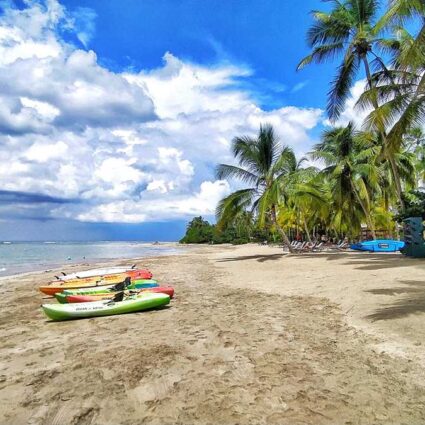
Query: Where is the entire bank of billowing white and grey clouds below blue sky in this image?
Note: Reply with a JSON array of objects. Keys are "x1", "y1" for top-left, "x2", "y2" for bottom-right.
[{"x1": 0, "y1": 0, "x2": 322, "y2": 222}]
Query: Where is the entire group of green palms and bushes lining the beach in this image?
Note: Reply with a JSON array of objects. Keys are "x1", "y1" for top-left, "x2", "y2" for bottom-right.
[{"x1": 184, "y1": 0, "x2": 425, "y2": 251}]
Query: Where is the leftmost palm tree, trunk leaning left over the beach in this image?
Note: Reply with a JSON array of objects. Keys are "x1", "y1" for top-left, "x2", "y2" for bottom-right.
[{"x1": 216, "y1": 124, "x2": 298, "y2": 252}]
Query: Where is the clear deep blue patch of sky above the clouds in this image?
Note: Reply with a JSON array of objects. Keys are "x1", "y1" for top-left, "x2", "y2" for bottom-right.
[{"x1": 63, "y1": 0, "x2": 334, "y2": 109}]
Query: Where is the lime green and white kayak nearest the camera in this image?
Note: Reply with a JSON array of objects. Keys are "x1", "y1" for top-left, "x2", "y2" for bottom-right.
[{"x1": 42, "y1": 293, "x2": 170, "y2": 320}]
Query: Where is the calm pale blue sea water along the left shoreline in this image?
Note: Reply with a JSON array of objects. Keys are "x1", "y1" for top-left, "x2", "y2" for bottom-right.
[{"x1": 0, "y1": 242, "x2": 180, "y2": 276}]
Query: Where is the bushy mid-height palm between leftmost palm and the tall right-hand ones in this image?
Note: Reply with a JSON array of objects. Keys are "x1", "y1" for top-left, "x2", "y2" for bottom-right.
[{"x1": 310, "y1": 123, "x2": 379, "y2": 239}]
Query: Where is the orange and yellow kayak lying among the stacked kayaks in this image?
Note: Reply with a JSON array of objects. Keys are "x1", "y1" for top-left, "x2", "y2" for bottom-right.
[{"x1": 39, "y1": 269, "x2": 152, "y2": 295}]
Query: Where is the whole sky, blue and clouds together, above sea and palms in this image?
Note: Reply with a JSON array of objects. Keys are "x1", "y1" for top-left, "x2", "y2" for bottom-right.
[{"x1": 0, "y1": 0, "x2": 360, "y2": 240}]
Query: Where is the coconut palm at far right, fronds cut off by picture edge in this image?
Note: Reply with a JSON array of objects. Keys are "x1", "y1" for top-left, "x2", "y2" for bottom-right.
[{"x1": 358, "y1": 0, "x2": 425, "y2": 202}]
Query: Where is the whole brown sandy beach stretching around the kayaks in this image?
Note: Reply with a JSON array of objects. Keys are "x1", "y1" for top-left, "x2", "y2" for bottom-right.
[{"x1": 0, "y1": 245, "x2": 425, "y2": 425}]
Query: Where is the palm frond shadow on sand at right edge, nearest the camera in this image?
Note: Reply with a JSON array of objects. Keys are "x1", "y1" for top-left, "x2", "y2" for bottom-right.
[{"x1": 365, "y1": 280, "x2": 425, "y2": 322}]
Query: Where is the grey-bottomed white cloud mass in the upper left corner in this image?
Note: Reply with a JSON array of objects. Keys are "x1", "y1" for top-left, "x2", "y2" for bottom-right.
[{"x1": 0, "y1": 9, "x2": 154, "y2": 132}]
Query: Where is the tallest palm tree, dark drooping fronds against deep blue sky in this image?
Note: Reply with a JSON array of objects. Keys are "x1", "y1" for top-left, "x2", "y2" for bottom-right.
[{"x1": 297, "y1": 0, "x2": 404, "y2": 208}]
